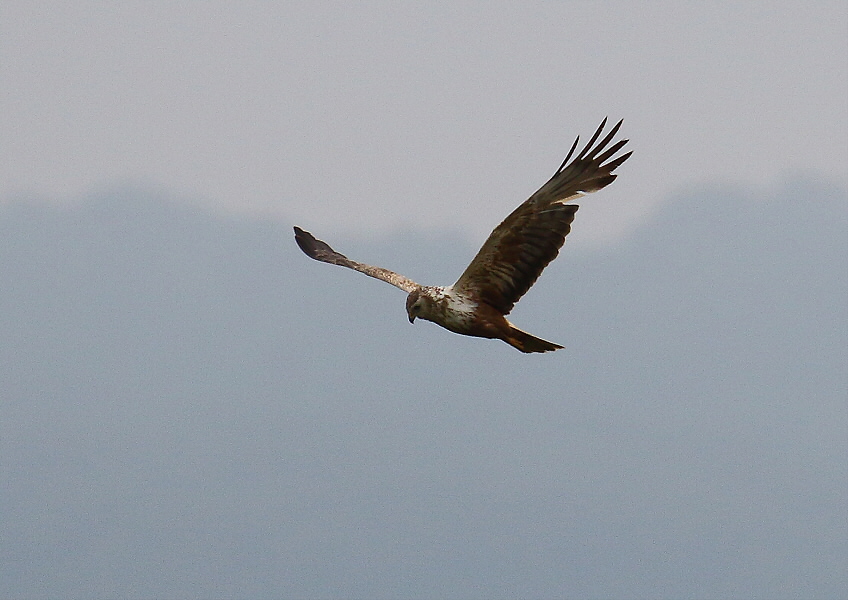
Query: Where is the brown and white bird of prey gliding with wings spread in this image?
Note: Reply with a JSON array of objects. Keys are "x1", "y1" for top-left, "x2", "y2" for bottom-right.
[{"x1": 294, "y1": 119, "x2": 631, "y2": 353}]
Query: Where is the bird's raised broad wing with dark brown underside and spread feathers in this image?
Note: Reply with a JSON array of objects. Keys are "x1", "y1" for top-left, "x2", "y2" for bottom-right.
[{"x1": 453, "y1": 119, "x2": 631, "y2": 315}]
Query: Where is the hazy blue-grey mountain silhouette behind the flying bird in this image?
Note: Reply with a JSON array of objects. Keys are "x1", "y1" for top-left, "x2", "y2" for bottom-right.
[{"x1": 0, "y1": 180, "x2": 848, "y2": 598}]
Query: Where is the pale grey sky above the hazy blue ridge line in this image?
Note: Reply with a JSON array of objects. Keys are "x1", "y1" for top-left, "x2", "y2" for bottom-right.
[{"x1": 0, "y1": 0, "x2": 848, "y2": 241}]
